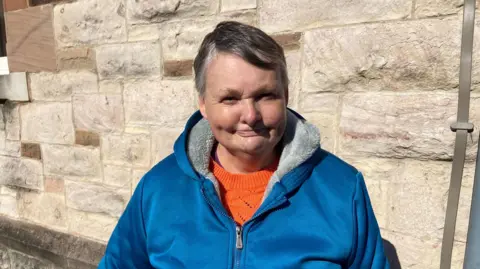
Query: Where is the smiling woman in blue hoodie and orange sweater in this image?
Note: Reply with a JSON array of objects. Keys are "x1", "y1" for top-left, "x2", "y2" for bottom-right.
[{"x1": 99, "y1": 22, "x2": 389, "y2": 269}]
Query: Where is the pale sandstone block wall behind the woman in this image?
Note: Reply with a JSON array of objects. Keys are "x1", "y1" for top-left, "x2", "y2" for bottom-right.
[{"x1": 0, "y1": 0, "x2": 480, "y2": 269}]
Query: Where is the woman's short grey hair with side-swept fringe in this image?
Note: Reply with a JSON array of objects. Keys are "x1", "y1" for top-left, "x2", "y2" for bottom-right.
[{"x1": 193, "y1": 21, "x2": 288, "y2": 96}]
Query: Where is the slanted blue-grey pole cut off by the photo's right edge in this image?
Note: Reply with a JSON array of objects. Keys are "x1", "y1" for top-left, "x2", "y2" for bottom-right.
[{"x1": 463, "y1": 131, "x2": 480, "y2": 269}]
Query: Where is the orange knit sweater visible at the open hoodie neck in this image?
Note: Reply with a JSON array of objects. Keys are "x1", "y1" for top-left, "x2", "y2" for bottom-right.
[{"x1": 210, "y1": 159, "x2": 278, "y2": 225}]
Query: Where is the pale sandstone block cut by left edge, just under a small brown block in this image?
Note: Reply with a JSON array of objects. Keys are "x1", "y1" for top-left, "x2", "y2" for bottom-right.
[{"x1": 0, "y1": 156, "x2": 43, "y2": 189}]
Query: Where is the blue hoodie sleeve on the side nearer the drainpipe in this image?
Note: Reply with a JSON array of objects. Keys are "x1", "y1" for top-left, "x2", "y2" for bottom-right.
[{"x1": 349, "y1": 173, "x2": 390, "y2": 269}]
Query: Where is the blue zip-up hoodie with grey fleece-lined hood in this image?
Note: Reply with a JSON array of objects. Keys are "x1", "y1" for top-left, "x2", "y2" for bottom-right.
[{"x1": 98, "y1": 110, "x2": 389, "y2": 269}]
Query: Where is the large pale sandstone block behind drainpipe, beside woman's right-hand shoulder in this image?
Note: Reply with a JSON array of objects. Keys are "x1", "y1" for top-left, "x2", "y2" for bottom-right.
[{"x1": 345, "y1": 157, "x2": 475, "y2": 241}]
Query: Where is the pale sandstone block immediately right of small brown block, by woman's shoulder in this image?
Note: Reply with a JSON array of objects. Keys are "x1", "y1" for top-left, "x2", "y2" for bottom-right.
[{"x1": 102, "y1": 134, "x2": 150, "y2": 166}]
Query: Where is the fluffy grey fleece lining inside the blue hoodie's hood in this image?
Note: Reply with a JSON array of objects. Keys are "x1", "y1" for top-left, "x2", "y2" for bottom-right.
[{"x1": 187, "y1": 111, "x2": 320, "y2": 202}]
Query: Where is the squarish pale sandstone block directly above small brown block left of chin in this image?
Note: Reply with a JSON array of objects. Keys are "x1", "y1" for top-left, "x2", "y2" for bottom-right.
[{"x1": 73, "y1": 94, "x2": 124, "y2": 132}]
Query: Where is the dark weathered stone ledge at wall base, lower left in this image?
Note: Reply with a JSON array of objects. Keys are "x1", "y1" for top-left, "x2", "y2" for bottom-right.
[{"x1": 0, "y1": 216, "x2": 106, "y2": 269}]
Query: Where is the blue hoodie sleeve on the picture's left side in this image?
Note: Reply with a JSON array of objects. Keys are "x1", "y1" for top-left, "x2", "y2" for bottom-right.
[{"x1": 98, "y1": 178, "x2": 152, "y2": 269}]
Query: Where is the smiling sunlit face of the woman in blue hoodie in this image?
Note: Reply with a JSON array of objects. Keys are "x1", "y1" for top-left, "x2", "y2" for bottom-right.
[{"x1": 199, "y1": 53, "x2": 288, "y2": 156}]
